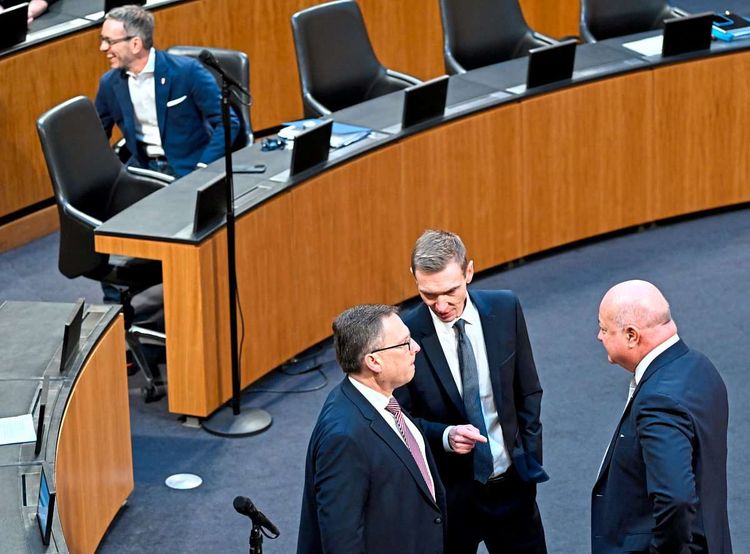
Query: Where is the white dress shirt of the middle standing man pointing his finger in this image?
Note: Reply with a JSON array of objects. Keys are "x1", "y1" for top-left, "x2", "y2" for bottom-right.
[{"x1": 430, "y1": 296, "x2": 510, "y2": 477}]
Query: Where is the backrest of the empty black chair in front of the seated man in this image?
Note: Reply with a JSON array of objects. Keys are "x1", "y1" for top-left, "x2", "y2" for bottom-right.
[{"x1": 37, "y1": 96, "x2": 122, "y2": 278}]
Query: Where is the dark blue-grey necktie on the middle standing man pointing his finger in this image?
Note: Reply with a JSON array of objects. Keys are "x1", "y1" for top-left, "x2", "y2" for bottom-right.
[{"x1": 453, "y1": 319, "x2": 494, "y2": 483}]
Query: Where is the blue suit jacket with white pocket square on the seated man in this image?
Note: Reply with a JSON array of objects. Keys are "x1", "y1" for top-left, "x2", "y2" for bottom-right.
[{"x1": 96, "y1": 50, "x2": 240, "y2": 176}]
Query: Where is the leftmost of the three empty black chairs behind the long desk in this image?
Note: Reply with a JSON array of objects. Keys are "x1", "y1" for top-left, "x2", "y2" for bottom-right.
[{"x1": 292, "y1": 0, "x2": 421, "y2": 117}]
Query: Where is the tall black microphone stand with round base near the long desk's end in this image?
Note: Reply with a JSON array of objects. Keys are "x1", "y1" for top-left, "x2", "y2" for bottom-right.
[{"x1": 201, "y1": 66, "x2": 272, "y2": 436}]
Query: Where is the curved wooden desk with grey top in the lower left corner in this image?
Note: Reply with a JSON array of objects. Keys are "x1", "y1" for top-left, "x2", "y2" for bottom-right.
[{"x1": 0, "y1": 302, "x2": 133, "y2": 553}]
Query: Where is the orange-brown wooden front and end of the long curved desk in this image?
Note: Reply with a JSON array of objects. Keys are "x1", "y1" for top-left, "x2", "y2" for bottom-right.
[{"x1": 96, "y1": 37, "x2": 750, "y2": 416}]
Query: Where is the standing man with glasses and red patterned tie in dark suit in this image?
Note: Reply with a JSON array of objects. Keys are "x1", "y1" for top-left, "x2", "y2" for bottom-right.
[{"x1": 297, "y1": 305, "x2": 445, "y2": 554}]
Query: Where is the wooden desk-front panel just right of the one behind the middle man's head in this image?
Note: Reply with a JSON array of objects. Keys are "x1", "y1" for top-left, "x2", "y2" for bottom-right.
[{"x1": 521, "y1": 71, "x2": 654, "y2": 253}]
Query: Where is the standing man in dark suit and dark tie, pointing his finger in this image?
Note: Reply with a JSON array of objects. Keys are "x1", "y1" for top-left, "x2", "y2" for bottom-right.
[{"x1": 396, "y1": 231, "x2": 547, "y2": 554}]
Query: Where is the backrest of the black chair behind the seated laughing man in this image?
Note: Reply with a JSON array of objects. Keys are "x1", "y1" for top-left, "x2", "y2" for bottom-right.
[{"x1": 167, "y1": 46, "x2": 253, "y2": 150}]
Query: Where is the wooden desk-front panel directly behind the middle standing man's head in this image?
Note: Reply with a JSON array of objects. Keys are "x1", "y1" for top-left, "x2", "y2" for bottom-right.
[{"x1": 402, "y1": 104, "x2": 522, "y2": 272}]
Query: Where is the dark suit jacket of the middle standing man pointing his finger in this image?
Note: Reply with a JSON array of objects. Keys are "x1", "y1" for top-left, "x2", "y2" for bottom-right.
[{"x1": 394, "y1": 291, "x2": 547, "y2": 492}]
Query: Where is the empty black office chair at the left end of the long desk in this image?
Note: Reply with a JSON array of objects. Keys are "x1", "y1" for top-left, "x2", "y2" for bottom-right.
[{"x1": 37, "y1": 96, "x2": 166, "y2": 401}]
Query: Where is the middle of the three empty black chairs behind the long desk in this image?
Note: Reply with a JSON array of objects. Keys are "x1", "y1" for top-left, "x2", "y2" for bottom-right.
[{"x1": 440, "y1": 0, "x2": 557, "y2": 75}]
